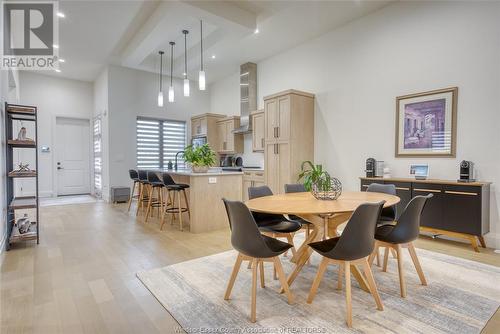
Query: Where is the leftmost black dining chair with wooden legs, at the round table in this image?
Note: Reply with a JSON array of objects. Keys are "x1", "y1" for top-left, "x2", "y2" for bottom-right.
[{"x1": 222, "y1": 199, "x2": 294, "y2": 322}]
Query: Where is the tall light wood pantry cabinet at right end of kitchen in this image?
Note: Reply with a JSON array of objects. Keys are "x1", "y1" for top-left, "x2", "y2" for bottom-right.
[{"x1": 264, "y1": 90, "x2": 314, "y2": 194}]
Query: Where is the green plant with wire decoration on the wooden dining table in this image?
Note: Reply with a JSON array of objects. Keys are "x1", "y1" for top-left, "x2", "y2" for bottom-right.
[{"x1": 299, "y1": 161, "x2": 342, "y2": 200}]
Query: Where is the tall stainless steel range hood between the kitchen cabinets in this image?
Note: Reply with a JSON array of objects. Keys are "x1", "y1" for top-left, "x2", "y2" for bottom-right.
[{"x1": 233, "y1": 63, "x2": 257, "y2": 134}]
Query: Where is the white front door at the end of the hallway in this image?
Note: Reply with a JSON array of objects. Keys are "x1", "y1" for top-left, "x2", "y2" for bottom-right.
[{"x1": 55, "y1": 117, "x2": 90, "y2": 195}]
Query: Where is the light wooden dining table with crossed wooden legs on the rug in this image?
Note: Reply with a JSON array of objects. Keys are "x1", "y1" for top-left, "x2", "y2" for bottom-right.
[{"x1": 245, "y1": 191, "x2": 400, "y2": 292}]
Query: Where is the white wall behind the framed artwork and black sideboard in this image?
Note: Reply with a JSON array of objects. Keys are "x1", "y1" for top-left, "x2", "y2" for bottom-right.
[{"x1": 211, "y1": 1, "x2": 500, "y2": 247}]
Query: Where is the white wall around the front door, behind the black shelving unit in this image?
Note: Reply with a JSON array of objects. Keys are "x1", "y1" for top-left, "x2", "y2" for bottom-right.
[{"x1": 19, "y1": 71, "x2": 94, "y2": 197}]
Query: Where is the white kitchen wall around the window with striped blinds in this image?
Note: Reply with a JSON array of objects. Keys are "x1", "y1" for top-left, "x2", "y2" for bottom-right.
[{"x1": 108, "y1": 66, "x2": 210, "y2": 194}]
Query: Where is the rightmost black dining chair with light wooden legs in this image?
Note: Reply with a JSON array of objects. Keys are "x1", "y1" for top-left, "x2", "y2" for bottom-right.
[{"x1": 370, "y1": 194, "x2": 432, "y2": 298}]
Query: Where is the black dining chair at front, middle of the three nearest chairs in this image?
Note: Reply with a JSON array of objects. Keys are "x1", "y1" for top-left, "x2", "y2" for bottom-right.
[{"x1": 307, "y1": 201, "x2": 385, "y2": 327}]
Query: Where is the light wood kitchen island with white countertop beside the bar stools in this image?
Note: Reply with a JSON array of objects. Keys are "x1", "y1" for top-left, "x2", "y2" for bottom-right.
[{"x1": 159, "y1": 168, "x2": 243, "y2": 233}]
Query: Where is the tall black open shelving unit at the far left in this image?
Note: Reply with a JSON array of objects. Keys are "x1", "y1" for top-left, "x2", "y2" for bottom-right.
[{"x1": 5, "y1": 103, "x2": 40, "y2": 250}]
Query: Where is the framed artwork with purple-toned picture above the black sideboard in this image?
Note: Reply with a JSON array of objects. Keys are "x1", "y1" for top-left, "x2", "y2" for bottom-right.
[{"x1": 396, "y1": 87, "x2": 458, "y2": 157}]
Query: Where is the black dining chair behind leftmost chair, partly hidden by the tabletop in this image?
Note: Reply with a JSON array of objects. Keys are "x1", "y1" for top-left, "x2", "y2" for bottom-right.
[{"x1": 248, "y1": 186, "x2": 302, "y2": 255}]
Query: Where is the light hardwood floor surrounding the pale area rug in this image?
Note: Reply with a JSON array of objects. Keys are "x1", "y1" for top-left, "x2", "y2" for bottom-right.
[{"x1": 0, "y1": 203, "x2": 500, "y2": 334}]
